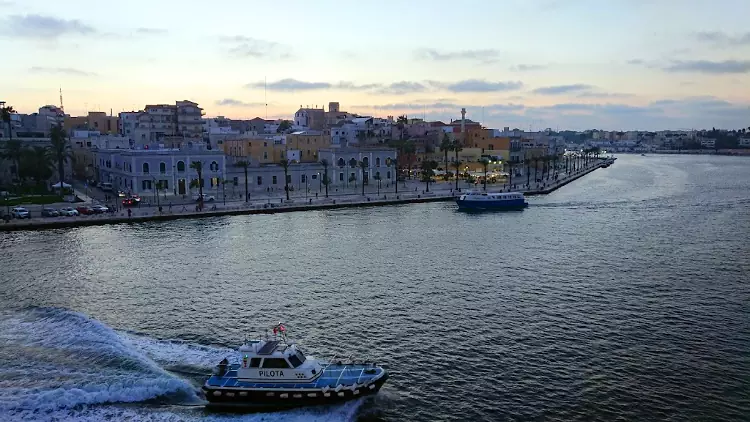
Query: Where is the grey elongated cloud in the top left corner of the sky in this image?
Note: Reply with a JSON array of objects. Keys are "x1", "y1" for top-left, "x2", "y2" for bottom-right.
[{"x1": 0, "y1": 14, "x2": 98, "y2": 40}]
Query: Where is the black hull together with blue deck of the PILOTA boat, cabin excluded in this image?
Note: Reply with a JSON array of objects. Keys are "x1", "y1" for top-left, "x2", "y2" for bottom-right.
[{"x1": 203, "y1": 365, "x2": 388, "y2": 409}]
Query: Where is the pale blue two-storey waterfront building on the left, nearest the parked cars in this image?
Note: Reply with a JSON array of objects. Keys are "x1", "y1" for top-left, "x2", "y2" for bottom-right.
[{"x1": 94, "y1": 143, "x2": 226, "y2": 195}]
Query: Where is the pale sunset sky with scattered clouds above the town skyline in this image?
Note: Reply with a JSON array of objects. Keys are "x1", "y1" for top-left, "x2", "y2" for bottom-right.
[{"x1": 0, "y1": 0, "x2": 750, "y2": 130}]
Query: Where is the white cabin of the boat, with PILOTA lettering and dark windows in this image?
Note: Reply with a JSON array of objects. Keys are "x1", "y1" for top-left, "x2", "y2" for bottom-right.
[{"x1": 237, "y1": 340, "x2": 323, "y2": 383}]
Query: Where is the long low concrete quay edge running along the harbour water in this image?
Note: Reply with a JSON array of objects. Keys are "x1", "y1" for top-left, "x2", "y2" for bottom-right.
[{"x1": 0, "y1": 160, "x2": 612, "y2": 231}]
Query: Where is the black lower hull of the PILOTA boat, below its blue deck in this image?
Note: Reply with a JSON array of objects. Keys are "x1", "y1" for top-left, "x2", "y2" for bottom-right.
[{"x1": 203, "y1": 373, "x2": 388, "y2": 408}]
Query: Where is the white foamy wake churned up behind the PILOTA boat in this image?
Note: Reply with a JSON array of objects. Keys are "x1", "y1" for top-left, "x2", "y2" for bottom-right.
[{"x1": 0, "y1": 307, "x2": 370, "y2": 421}]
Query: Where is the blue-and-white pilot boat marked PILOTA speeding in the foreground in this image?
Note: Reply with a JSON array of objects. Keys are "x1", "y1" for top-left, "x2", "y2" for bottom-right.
[{"x1": 203, "y1": 323, "x2": 388, "y2": 407}]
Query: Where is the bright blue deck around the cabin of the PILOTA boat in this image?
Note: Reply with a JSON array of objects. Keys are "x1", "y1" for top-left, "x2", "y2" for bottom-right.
[{"x1": 206, "y1": 364, "x2": 383, "y2": 389}]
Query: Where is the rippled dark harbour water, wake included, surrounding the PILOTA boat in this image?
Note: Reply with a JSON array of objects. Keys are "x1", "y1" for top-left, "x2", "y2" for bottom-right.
[{"x1": 0, "y1": 156, "x2": 750, "y2": 421}]
